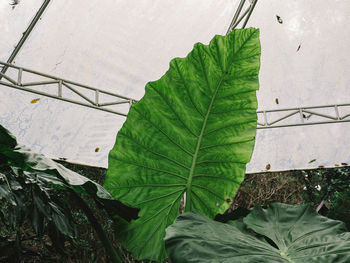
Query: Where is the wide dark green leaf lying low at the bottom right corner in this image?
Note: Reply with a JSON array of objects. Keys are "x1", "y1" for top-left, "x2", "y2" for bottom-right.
[{"x1": 166, "y1": 203, "x2": 350, "y2": 263}]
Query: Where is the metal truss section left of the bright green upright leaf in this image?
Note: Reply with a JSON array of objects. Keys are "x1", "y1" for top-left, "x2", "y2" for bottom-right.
[{"x1": 0, "y1": 61, "x2": 136, "y2": 117}]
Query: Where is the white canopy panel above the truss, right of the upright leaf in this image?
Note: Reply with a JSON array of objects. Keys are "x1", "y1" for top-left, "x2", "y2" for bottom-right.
[{"x1": 248, "y1": 0, "x2": 350, "y2": 109}]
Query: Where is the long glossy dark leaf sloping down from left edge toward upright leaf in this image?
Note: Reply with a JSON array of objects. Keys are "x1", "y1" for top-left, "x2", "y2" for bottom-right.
[{"x1": 0, "y1": 125, "x2": 138, "y2": 221}]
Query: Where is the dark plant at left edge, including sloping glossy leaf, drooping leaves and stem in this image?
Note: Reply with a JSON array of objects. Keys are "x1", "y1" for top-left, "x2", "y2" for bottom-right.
[{"x1": 0, "y1": 126, "x2": 138, "y2": 262}]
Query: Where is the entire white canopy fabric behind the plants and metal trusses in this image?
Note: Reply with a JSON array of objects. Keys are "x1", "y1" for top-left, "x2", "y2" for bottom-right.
[{"x1": 0, "y1": 0, "x2": 350, "y2": 172}]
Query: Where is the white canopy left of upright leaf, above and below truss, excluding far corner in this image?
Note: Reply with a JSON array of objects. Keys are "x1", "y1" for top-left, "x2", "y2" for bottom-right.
[{"x1": 0, "y1": 0, "x2": 237, "y2": 166}]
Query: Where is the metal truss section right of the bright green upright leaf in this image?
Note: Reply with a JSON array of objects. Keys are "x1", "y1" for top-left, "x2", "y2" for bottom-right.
[{"x1": 257, "y1": 104, "x2": 350, "y2": 129}]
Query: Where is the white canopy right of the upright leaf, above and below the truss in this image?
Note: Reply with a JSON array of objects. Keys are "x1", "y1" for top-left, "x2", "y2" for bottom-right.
[{"x1": 243, "y1": 0, "x2": 350, "y2": 172}]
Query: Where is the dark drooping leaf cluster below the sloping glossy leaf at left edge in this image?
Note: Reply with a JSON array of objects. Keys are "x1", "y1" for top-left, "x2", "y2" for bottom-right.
[{"x1": 0, "y1": 151, "x2": 76, "y2": 252}]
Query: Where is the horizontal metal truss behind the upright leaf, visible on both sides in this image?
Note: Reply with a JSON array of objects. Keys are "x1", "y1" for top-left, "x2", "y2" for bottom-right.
[{"x1": 0, "y1": 61, "x2": 350, "y2": 129}]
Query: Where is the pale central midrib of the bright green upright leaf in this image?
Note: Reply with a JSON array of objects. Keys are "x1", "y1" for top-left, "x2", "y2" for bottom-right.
[{"x1": 185, "y1": 31, "x2": 255, "y2": 212}]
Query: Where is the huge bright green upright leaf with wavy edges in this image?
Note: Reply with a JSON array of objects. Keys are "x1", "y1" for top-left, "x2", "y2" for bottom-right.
[{"x1": 105, "y1": 28, "x2": 260, "y2": 260}]
